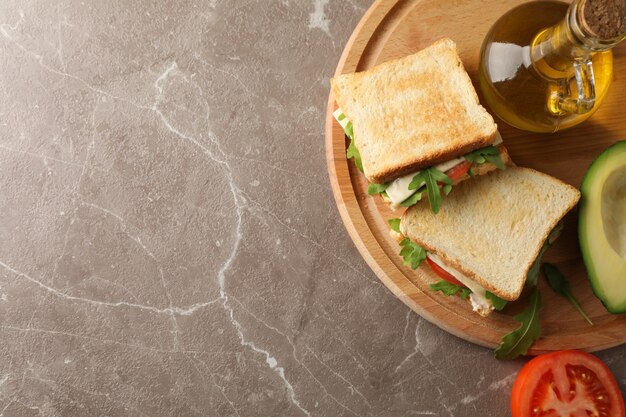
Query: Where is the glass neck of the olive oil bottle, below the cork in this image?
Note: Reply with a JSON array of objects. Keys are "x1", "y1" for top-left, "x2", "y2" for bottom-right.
[{"x1": 530, "y1": 0, "x2": 626, "y2": 80}]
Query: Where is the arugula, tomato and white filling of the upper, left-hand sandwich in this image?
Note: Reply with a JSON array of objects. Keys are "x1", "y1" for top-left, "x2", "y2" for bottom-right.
[{"x1": 333, "y1": 109, "x2": 504, "y2": 212}]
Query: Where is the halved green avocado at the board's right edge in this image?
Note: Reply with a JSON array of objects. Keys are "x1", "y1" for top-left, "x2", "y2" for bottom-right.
[{"x1": 578, "y1": 141, "x2": 626, "y2": 313}]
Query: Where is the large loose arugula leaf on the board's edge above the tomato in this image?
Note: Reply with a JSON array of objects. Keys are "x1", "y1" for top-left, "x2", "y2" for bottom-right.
[{"x1": 494, "y1": 287, "x2": 542, "y2": 359}]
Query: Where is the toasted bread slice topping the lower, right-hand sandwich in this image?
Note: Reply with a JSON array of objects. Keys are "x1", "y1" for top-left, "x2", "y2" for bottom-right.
[{"x1": 400, "y1": 167, "x2": 580, "y2": 301}]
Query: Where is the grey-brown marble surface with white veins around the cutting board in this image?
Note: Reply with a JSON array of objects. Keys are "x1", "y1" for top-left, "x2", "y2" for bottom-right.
[{"x1": 0, "y1": 0, "x2": 626, "y2": 417}]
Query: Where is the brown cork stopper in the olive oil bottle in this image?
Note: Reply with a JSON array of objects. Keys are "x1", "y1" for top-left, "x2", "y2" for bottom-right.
[{"x1": 581, "y1": 0, "x2": 626, "y2": 40}]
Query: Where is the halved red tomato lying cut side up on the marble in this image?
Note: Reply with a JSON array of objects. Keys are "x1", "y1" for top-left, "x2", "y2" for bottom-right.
[{"x1": 511, "y1": 350, "x2": 624, "y2": 417}]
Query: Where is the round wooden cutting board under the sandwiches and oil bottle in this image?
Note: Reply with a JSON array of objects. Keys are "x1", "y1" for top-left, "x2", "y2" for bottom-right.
[{"x1": 326, "y1": 0, "x2": 626, "y2": 354}]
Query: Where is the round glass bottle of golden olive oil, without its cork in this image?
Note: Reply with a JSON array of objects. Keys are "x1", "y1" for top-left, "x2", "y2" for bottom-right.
[{"x1": 479, "y1": 0, "x2": 626, "y2": 132}]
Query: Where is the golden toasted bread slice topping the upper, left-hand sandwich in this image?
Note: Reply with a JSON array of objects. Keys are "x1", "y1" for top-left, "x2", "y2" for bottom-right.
[{"x1": 331, "y1": 39, "x2": 497, "y2": 184}]
